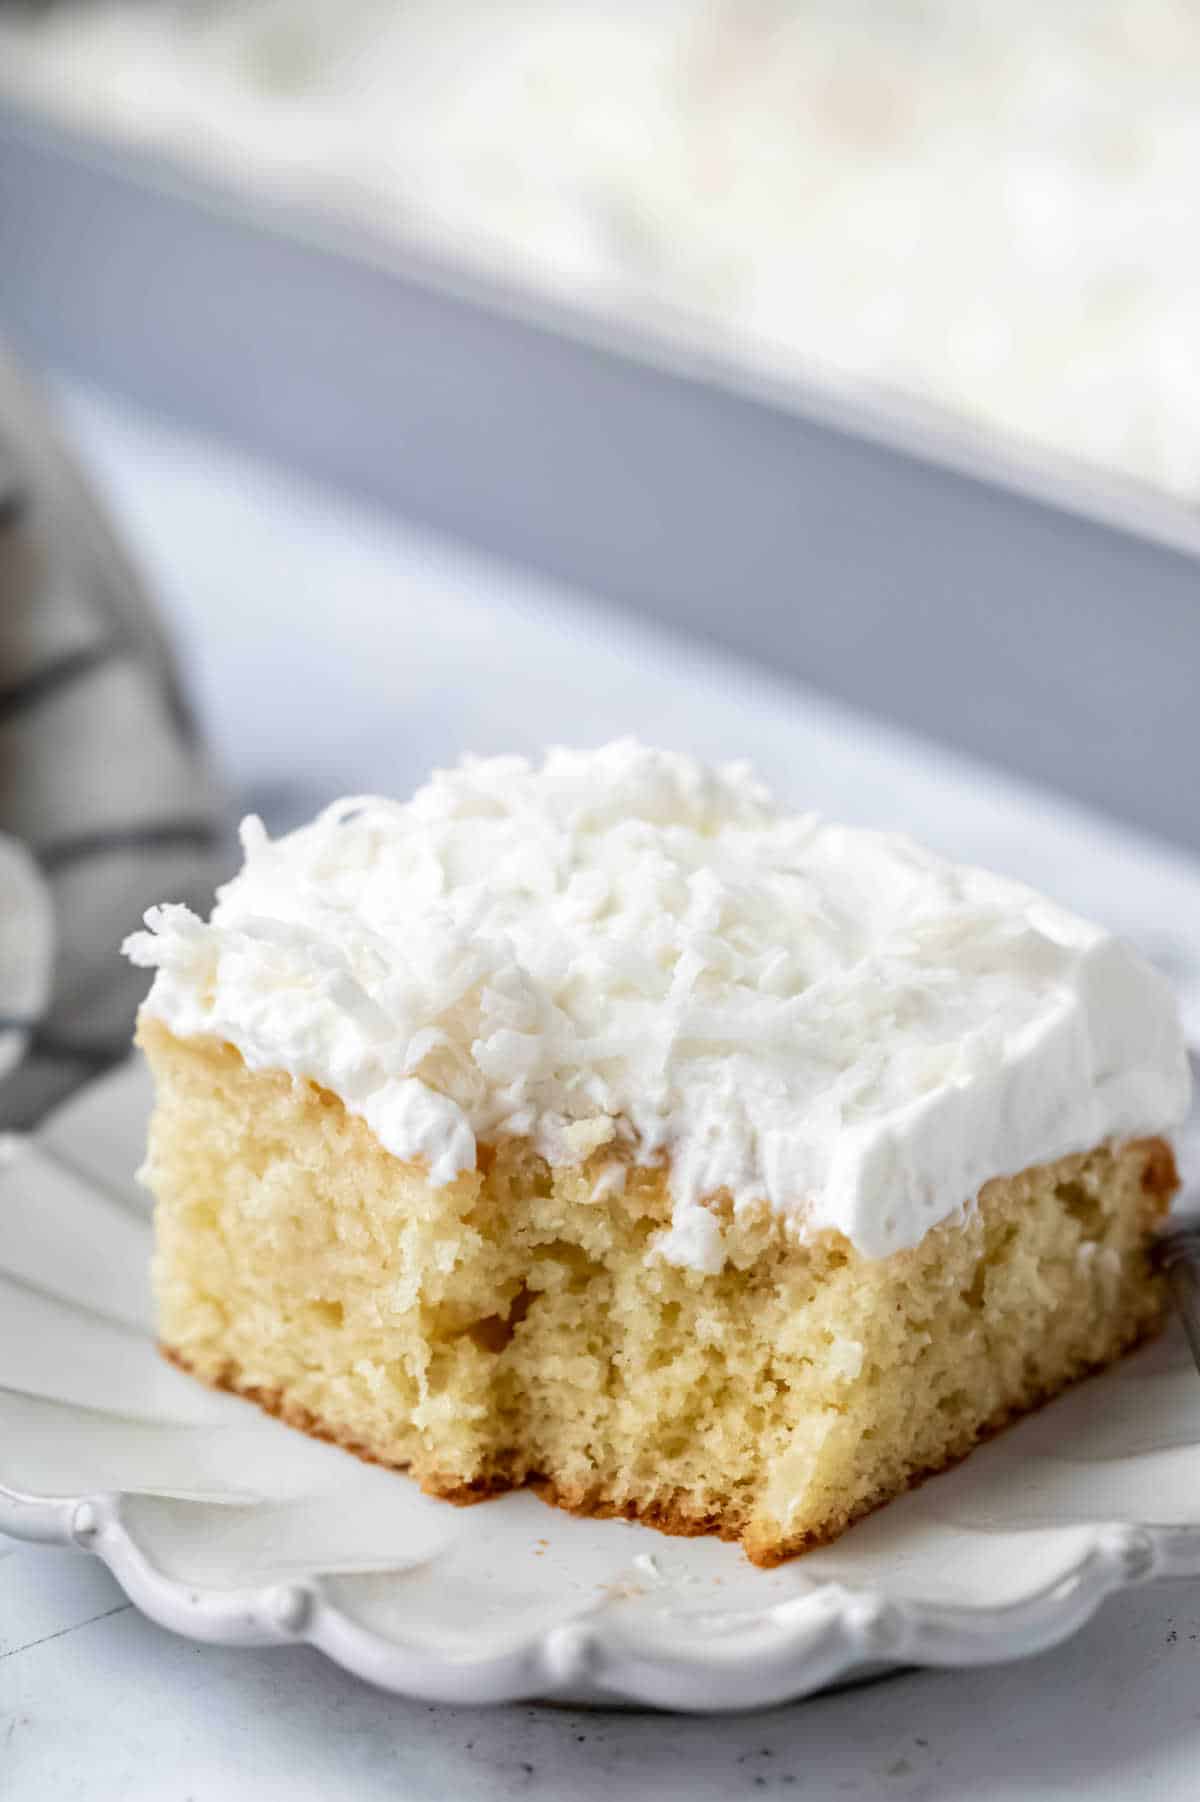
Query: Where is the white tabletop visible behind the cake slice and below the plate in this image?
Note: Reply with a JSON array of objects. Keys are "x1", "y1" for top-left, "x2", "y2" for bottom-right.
[{"x1": 0, "y1": 380, "x2": 1200, "y2": 1802}]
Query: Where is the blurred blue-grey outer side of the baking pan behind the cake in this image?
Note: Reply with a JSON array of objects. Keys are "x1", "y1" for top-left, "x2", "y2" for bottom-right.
[{"x1": 0, "y1": 108, "x2": 1200, "y2": 847}]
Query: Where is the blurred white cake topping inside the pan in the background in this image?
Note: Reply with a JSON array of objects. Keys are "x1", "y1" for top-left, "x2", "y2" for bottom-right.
[{"x1": 0, "y1": 0, "x2": 1200, "y2": 505}]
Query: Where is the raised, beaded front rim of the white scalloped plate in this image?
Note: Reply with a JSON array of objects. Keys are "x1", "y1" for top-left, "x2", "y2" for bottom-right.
[{"x1": 0, "y1": 1483, "x2": 1200, "y2": 1714}]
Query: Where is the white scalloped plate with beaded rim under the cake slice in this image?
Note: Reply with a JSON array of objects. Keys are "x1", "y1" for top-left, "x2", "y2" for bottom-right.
[{"x1": 0, "y1": 1065, "x2": 1200, "y2": 1710}]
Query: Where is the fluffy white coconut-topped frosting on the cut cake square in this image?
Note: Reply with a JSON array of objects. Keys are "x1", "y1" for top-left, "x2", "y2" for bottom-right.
[{"x1": 126, "y1": 741, "x2": 1189, "y2": 1270}]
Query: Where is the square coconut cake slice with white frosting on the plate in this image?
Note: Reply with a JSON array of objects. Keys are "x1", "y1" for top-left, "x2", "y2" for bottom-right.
[{"x1": 126, "y1": 742, "x2": 1189, "y2": 1564}]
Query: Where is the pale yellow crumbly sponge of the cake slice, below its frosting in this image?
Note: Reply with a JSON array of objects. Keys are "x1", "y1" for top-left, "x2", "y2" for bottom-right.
[{"x1": 141, "y1": 1020, "x2": 1177, "y2": 1564}]
